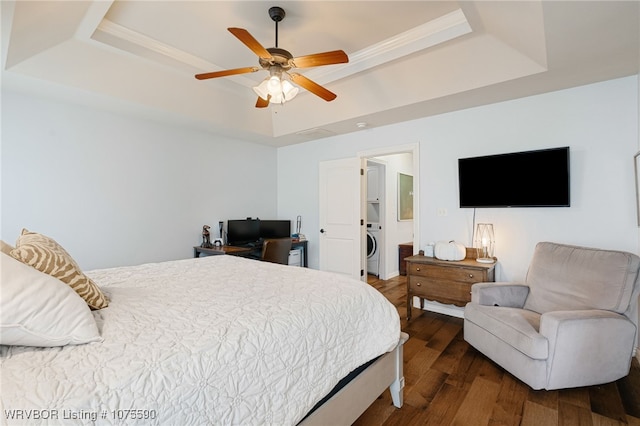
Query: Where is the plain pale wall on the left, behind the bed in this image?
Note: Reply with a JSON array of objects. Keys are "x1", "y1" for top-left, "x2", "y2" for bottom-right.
[{"x1": 1, "y1": 92, "x2": 278, "y2": 269}]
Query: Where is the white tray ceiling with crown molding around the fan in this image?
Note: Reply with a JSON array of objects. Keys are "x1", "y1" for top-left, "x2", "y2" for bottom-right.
[{"x1": 1, "y1": 0, "x2": 640, "y2": 146}]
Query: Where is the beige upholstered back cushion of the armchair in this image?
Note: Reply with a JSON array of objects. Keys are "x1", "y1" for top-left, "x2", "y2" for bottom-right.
[{"x1": 524, "y1": 242, "x2": 640, "y2": 314}]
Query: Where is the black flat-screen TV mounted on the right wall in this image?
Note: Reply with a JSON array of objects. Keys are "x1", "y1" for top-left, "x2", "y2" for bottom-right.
[{"x1": 458, "y1": 147, "x2": 570, "y2": 208}]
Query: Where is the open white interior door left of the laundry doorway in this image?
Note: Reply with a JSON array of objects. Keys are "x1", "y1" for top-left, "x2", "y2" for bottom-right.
[{"x1": 319, "y1": 158, "x2": 366, "y2": 279}]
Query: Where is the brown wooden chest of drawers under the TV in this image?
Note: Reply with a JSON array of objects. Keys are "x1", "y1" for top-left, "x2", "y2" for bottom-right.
[{"x1": 406, "y1": 255, "x2": 495, "y2": 319}]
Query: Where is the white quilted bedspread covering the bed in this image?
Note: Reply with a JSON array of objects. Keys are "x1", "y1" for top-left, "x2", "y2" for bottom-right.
[{"x1": 0, "y1": 256, "x2": 400, "y2": 425}]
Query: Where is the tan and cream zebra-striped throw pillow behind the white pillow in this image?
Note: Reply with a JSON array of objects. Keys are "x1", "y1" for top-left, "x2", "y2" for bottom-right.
[{"x1": 11, "y1": 229, "x2": 109, "y2": 309}]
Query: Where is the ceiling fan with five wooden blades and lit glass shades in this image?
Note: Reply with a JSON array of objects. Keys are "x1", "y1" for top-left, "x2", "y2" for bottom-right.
[{"x1": 195, "y1": 6, "x2": 349, "y2": 108}]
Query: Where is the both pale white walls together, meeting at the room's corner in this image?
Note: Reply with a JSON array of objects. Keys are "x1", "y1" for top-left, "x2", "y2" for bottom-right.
[{"x1": 1, "y1": 76, "x2": 640, "y2": 279}]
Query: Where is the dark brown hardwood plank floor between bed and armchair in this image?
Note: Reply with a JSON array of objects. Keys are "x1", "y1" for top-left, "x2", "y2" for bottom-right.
[{"x1": 354, "y1": 276, "x2": 640, "y2": 426}]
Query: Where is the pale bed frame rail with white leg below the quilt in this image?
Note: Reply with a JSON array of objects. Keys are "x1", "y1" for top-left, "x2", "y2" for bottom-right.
[{"x1": 299, "y1": 333, "x2": 409, "y2": 426}]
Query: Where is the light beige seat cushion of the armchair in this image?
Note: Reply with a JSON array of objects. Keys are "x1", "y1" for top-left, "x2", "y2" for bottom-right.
[{"x1": 464, "y1": 303, "x2": 549, "y2": 360}]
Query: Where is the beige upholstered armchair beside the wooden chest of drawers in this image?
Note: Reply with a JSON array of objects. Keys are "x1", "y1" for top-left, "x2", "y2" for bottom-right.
[{"x1": 464, "y1": 242, "x2": 640, "y2": 389}]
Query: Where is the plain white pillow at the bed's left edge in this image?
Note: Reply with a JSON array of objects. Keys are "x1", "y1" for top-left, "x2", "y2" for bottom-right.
[{"x1": 0, "y1": 253, "x2": 102, "y2": 346}]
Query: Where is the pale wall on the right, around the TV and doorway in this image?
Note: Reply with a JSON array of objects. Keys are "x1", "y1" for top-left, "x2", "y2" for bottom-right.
[{"x1": 278, "y1": 76, "x2": 639, "y2": 280}]
